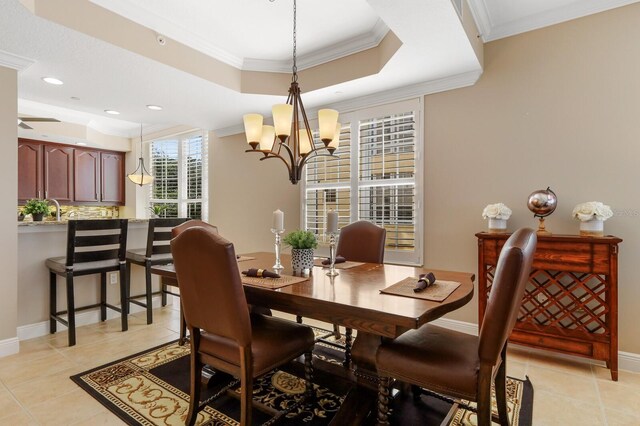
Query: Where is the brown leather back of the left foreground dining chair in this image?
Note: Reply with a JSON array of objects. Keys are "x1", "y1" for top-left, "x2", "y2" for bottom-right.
[{"x1": 171, "y1": 226, "x2": 251, "y2": 346}]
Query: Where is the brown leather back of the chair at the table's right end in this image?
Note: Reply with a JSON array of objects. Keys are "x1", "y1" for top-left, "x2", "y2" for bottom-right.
[{"x1": 478, "y1": 228, "x2": 538, "y2": 365}]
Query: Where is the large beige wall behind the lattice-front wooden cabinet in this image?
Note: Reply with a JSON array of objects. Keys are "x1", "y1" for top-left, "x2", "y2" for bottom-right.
[{"x1": 424, "y1": 4, "x2": 640, "y2": 353}]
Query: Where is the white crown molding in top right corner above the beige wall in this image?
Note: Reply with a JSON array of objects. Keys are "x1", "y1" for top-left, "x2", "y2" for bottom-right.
[{"x1": 469, "y1": 0, "x2": 638, "y2": 43}]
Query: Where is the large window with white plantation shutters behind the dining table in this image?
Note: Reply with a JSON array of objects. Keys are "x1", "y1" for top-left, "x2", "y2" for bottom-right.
[{"x1": 302, "y1": 99, "x2": 422, "y2": 264}]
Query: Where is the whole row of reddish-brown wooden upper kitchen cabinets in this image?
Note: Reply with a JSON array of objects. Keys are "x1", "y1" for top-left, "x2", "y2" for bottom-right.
[{"x1": 18, "y1": 139, "x2": 125, "y2": 205}]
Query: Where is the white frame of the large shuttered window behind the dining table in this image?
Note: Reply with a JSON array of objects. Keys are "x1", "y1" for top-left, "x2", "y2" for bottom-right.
[{"x1": 300, "y1": 98, "x2": 424, "y2": 266}]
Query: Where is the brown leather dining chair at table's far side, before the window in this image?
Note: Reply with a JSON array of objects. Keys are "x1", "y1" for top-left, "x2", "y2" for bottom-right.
[{"x1": 296, "y1": 220, "x2": 387, "y2": 367}]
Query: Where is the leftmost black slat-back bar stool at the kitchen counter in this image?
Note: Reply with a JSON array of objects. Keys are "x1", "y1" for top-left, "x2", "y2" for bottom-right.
[{"x1": 45, "y1": 219, "x2": 128, "y2": 346}]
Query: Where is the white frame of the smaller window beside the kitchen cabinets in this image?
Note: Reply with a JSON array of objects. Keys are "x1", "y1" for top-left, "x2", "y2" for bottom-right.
[{"x1": 145, "y1": 130, "x2": 209, "y2": 221}]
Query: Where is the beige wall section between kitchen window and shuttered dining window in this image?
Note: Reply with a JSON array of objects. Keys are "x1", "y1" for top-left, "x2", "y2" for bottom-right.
[{"x1": 209, "y1": 133, "x2": 300, "y2": 252}]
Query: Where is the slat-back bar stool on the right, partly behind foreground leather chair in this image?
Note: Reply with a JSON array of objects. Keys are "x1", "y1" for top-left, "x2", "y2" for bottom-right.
[{"x1": 126, "y1": 218, "x2": 189, "y2": 324}]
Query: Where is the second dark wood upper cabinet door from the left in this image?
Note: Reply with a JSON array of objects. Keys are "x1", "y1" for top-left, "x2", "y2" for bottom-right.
[{"x1": 44, "y1": 145, "x2": 74, "y2": 202}]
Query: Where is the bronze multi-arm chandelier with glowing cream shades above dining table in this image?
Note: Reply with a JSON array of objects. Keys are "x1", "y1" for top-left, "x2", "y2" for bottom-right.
[{"x1": 243, "y1": 0, "x2": 341, "y2": 185}]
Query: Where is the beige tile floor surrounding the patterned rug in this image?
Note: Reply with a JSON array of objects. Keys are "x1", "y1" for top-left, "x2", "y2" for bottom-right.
[{"x1": 0, "y1": 306, "x2": 640, "y2": 426}]
